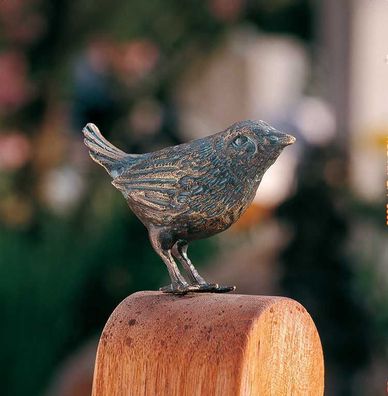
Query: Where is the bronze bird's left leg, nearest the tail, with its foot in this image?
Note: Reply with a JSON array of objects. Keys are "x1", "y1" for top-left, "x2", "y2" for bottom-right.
[{"x1": 150, "y1": 230, "x2": 189, "y2": 294}]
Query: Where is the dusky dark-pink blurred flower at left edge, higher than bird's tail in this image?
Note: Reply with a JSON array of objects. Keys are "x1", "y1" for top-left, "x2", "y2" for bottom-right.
[{"x1": 0, "y1": 51, "x2": 31, "y2": 110}]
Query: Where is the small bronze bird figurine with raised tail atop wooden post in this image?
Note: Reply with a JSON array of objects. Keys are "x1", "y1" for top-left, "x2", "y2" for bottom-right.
[{"x1": 83, "y1": 120, "x2": 296, "y2": 294}]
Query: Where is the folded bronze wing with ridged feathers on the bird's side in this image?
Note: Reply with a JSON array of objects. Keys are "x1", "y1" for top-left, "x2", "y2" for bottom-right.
[{"x1": 112, "y1": 139, "x2": 247, "y2": 218}]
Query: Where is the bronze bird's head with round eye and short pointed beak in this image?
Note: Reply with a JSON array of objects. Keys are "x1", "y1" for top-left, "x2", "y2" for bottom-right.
[{"x1": 223, "y1": 120, "x2": 296, "y2": 176}]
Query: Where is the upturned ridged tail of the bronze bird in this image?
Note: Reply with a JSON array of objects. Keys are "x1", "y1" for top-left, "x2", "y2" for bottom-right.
[{"x1": 82, "y1": 123, "x2": 131, "y2": 178}]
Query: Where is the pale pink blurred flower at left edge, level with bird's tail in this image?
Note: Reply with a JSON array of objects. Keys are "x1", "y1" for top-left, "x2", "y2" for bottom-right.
[{"x1": 0, "y1": 132, "x2": 31, "y2": 170}]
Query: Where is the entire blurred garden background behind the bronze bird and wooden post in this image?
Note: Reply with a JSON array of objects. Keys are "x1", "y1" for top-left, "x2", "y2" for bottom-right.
[{"x1": 0, "y1": 0, "x2": 388, "y2": 396}]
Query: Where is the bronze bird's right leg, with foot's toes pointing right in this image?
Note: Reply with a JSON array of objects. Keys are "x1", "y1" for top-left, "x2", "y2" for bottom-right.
[{"x1": 172, "y1": 240, "x2": 235, "y2": 293}]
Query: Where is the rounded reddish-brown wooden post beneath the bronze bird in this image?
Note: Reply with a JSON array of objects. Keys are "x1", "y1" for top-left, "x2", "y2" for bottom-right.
[{"x1": 92, "y1": 292, "x2": 324, "y2": 396}]
